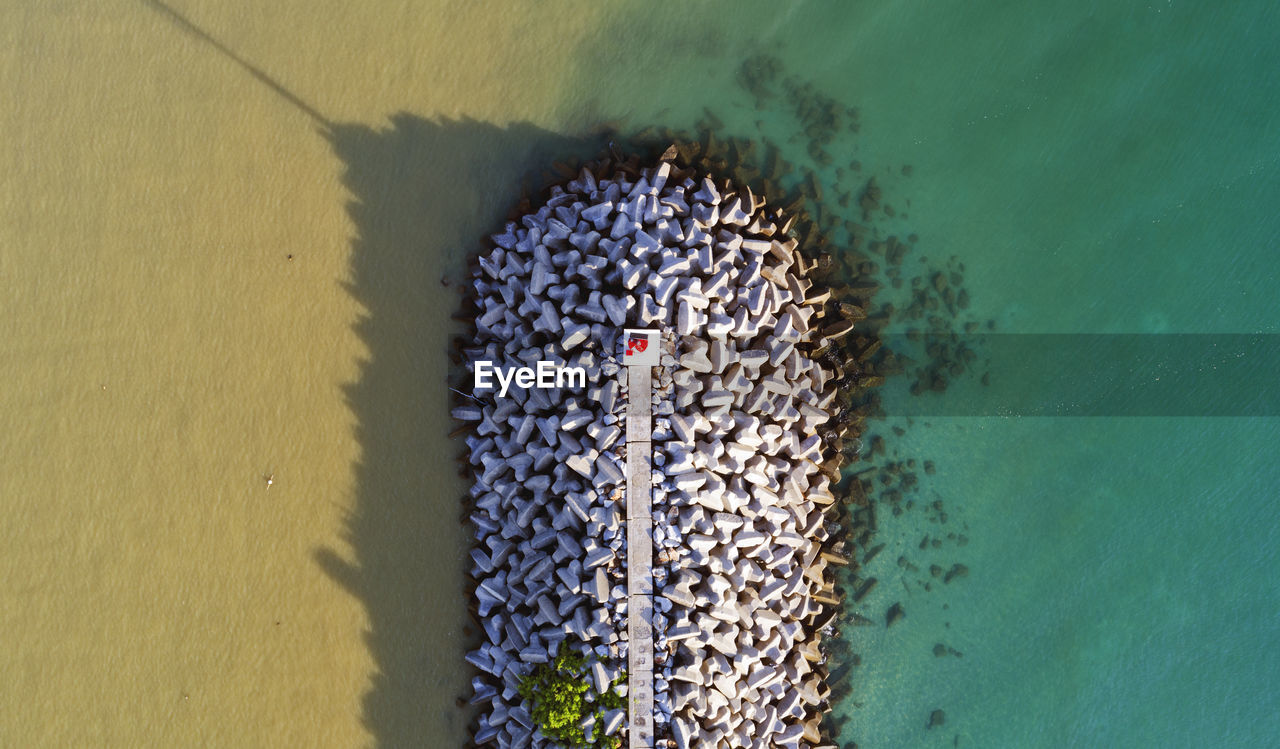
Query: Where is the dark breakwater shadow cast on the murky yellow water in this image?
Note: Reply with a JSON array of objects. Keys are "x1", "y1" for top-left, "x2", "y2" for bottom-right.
[{"x1": 315, "y1": 114, "x2": 595, "y2": 746}]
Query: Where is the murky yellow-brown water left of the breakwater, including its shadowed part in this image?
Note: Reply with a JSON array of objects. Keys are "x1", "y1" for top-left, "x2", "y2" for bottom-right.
[{"x1": 0, "y1": 0, "x2": 614, "y2": 746}]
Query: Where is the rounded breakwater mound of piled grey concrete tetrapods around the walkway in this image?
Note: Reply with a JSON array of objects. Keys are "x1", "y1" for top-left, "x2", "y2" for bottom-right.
[{"x1": 453, "y1": 147, "x2": 861, "y2": 746}]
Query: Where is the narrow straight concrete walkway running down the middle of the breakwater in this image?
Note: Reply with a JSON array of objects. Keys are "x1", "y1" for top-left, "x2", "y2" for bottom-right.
[{"x1": 626, "y1": 366, "x2": 653, "y2": 749}]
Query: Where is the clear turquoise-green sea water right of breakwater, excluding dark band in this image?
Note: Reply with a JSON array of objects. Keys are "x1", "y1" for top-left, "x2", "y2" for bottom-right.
[{"x1": 570, "y1": 0, "x2": 1280, "y2": 746}]
